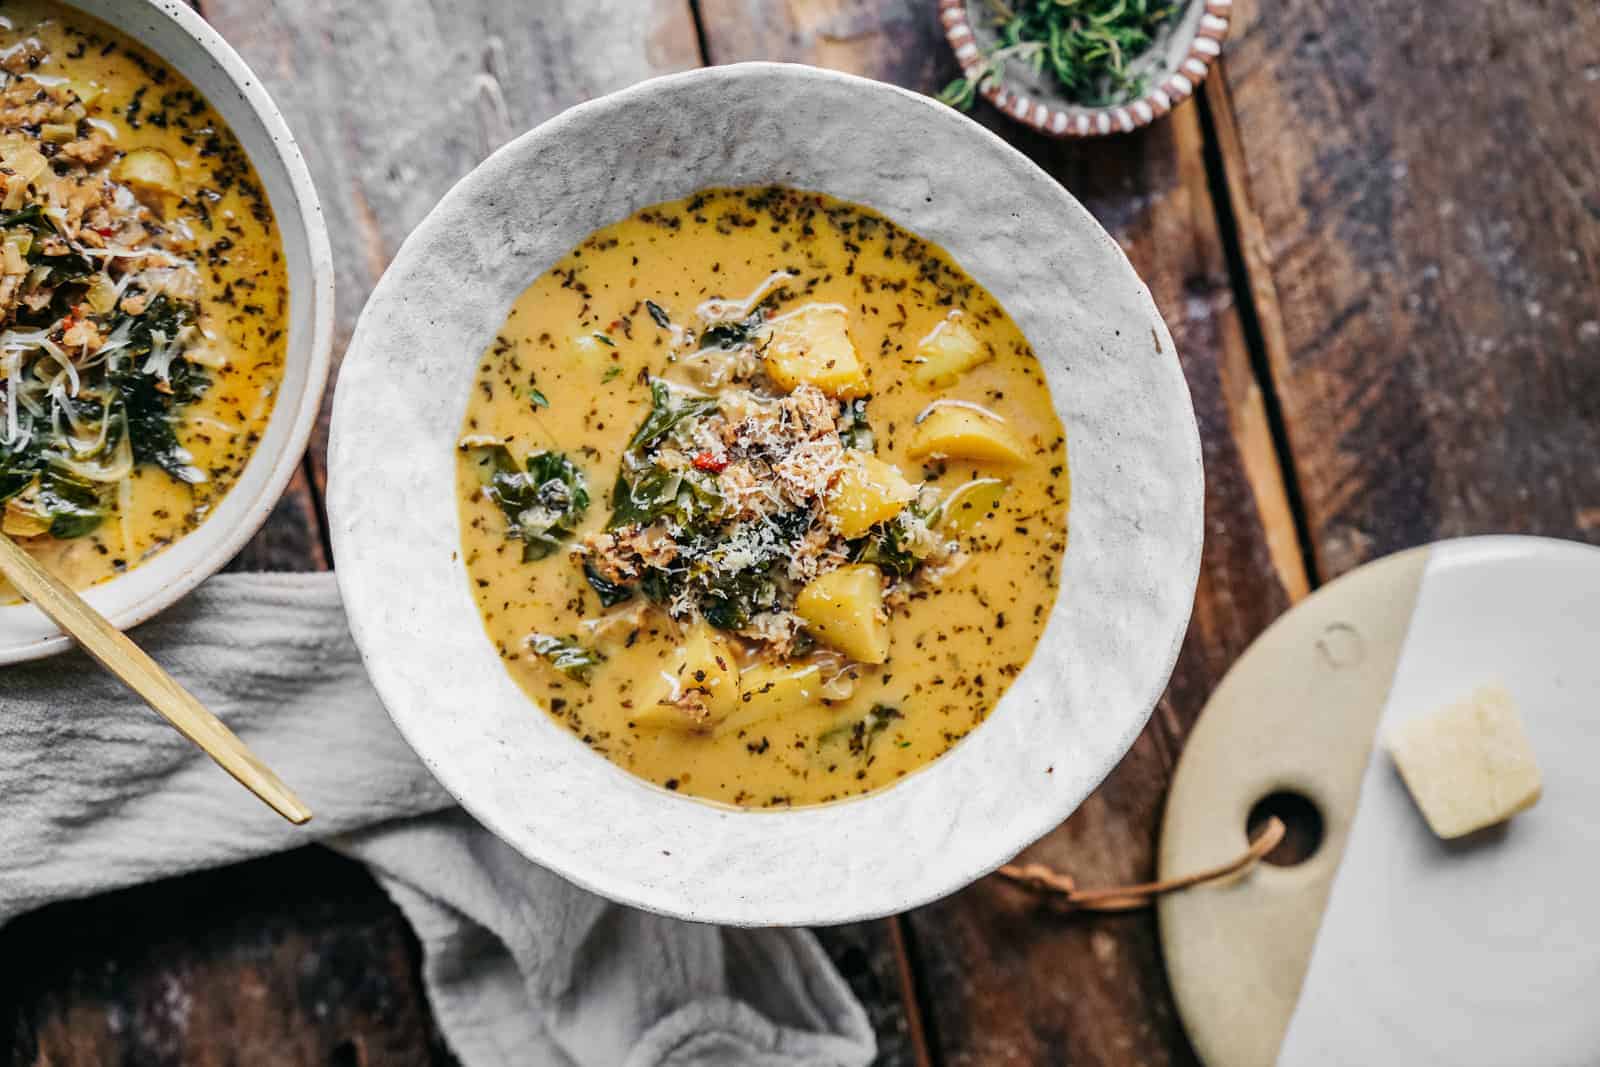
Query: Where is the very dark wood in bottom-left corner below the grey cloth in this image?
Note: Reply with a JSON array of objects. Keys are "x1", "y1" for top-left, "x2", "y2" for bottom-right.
[{"x1": 0, "y1": 848, "x2": 454, "y2": 1067}]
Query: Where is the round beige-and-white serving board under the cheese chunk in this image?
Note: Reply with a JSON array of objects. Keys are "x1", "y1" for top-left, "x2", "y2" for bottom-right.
[{"x1": 1158, "y1": 536, "x2": 1600, "y2": 1067}]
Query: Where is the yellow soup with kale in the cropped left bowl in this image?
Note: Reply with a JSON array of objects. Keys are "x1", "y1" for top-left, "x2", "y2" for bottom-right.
[{"x1": 0, "y1": 0, "x2": 288, "y2": 601}]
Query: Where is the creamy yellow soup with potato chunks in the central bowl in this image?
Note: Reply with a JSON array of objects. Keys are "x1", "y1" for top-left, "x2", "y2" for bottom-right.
[{"x1": 458, "y1": 189, "x2": 1069, "y2": 806}]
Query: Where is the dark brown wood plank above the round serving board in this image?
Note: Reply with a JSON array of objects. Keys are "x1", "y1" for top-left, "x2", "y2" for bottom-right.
[{"x1": 1226, "y1": 0, "x2": 1600, "y2": 577}]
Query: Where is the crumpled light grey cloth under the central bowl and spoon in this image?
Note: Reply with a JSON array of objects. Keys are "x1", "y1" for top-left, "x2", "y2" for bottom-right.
[{"x1": 0, "y1": 574, "x2": 874, "y2": 1067}]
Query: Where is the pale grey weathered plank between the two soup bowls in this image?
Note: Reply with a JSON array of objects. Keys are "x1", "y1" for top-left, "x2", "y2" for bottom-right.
[{"x1": 202, "y1": 0, "x2": 699, "y2": 488}]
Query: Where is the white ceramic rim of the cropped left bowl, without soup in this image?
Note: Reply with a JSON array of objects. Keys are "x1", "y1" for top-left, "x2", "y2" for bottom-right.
[{"x1": 0, "y1": 0, "x2": 333, "y2": 664}]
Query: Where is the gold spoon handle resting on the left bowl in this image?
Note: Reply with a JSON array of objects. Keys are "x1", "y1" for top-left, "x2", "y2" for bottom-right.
[{"x1": 0, "y1": 533, "x2": 310, "y2": 825}]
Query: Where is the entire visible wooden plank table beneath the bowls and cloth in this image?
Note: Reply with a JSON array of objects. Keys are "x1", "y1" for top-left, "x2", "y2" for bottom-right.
[{"x1": 0, "y1": 0, "x2": 1600, "y2": 1067}]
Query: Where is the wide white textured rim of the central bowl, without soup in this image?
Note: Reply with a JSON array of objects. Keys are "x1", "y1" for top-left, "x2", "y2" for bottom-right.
[{"x1": 328, "y1": 64, "x2": 1202, "y2": 925}]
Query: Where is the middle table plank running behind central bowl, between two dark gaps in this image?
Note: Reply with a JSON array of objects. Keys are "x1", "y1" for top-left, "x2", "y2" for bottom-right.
[{"x1": 701, "y1": 0, "x2": 1307, "y2": 1067}]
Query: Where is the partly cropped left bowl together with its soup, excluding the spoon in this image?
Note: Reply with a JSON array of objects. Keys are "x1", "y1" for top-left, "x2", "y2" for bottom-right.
[{"x1": 0, "y1": 0, "x2": 333, "y2": 664}]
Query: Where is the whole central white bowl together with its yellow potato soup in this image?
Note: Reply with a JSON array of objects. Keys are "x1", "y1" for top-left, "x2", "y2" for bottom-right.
[{"x1": 330, "y1": 64, "x2": 1200, "y2": 923}]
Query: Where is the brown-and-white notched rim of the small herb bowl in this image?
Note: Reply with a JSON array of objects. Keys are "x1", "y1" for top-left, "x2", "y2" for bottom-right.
[{"x1": 939, "y1": 0, "x2": 1234, "y2": 138}]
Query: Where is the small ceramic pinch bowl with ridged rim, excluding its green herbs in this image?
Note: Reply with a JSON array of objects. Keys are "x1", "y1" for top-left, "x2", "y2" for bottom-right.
[{"x1": 939, "y1": 0, "x2": 1234, "y2": 138}]
